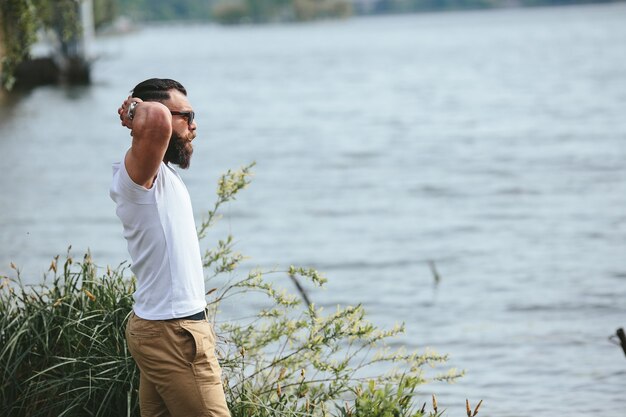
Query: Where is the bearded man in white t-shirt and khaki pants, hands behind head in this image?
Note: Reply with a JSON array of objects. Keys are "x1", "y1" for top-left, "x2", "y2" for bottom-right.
[{"x1": 110, "y1": 78, "x2": 230, "y2": 417}]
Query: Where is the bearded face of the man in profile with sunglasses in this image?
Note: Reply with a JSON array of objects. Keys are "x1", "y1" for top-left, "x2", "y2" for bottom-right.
[{"x1": 163, "y1": 90, "x2": 197, "y2": 169}]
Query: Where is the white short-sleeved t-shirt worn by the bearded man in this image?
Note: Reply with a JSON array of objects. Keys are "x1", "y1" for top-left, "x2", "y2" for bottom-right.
[{"x1": 110, "y1": 158, "x2": 206, "y2": 320}]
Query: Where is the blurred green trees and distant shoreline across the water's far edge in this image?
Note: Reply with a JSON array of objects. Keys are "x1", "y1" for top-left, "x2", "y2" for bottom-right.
[{"x1": 0, "y1": 0, "x2": 624, "y2": 90}]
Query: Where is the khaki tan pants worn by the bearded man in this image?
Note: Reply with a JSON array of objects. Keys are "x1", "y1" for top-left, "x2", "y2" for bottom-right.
[{"x1": 126, "y1": 313, "x2": 230, "y2": 417}]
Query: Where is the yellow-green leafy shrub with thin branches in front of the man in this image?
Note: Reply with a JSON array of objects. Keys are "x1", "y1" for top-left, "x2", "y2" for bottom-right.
[{"x1": 199, "y1": 162, "x2": 460, "y2": 416}]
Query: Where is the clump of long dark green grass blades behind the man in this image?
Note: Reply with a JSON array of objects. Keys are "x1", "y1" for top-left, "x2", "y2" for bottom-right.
[{"x1": 0, "y1": 251, "x2": 138, "y2": 416}]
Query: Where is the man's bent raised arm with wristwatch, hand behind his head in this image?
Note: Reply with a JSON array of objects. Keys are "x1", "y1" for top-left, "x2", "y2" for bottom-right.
[{"x1": 117, "y1": 97, "x2": 172, "y2": 188}]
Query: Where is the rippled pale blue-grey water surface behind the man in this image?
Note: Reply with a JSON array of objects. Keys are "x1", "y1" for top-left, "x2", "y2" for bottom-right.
[{"x1": 0, "y1": 4, "x2": 626, "y2": 417}]
